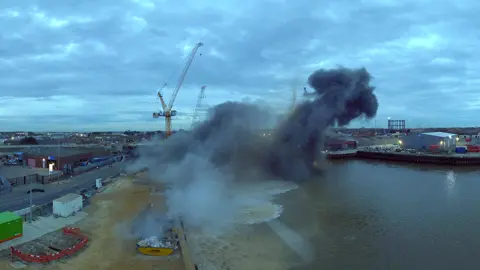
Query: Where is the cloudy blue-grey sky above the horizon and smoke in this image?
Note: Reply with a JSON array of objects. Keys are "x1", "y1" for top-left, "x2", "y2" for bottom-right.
[{"x1": 0, "y1": 0, "x2": 480, "y2": 131}]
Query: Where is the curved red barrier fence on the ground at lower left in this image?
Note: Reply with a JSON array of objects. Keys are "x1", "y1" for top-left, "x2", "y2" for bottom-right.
[{"x1": 10, "y1": 227, "x2": 88, "y2": 263}]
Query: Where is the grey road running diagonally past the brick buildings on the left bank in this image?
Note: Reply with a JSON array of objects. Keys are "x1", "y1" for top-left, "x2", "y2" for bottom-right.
[{"x1": 0, "y1": 162, "x2": 126, "y2": 212}]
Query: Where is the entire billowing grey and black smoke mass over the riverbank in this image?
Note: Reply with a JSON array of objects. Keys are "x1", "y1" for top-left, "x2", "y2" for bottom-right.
[{"x1": 131, "y1": 68, "x2": 378, "y2": 232}]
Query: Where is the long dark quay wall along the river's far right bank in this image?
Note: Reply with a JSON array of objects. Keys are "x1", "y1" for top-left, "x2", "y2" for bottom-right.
[{"x1": 327, "y1": 150, "x2": 480, "y2": 166}]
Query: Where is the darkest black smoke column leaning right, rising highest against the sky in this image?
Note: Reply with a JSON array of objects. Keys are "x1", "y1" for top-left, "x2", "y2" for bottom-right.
[{"x1": 269, "y1": 67, "x2": 378, "y2": 180}]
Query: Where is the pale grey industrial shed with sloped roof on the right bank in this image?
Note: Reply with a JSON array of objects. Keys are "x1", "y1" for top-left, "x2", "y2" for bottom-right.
[{"x1": 401, "y1": 132, "x2": 458, "y2": 151}]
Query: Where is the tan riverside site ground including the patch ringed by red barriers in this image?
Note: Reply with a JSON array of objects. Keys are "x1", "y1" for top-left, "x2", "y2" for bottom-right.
[{"x1": 0, "y1": 173, "x2": 185, "y2": 269}]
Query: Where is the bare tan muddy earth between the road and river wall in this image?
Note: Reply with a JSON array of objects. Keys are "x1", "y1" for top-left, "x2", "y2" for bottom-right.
[{"x1": 0, "y1": 175, "x2": 185, "y2": 270}]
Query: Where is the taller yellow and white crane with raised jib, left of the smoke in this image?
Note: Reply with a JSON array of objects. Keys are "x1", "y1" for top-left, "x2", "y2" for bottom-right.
[{"x1": 153, "y1": 42, "x2": 203, "y2": 138}]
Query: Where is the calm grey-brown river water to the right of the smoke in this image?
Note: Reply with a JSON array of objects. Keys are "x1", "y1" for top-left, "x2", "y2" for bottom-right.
[{"x1": 280, "y1": 161, "x2": 480, "y2": 270}]
